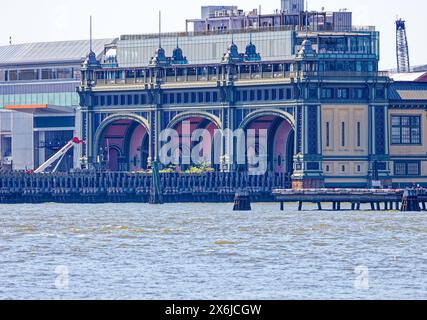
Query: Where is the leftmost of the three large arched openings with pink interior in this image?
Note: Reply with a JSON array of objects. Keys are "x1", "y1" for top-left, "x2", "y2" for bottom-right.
[{"x1": 95, "y1": 116, "x2": 149, "y2": 171}]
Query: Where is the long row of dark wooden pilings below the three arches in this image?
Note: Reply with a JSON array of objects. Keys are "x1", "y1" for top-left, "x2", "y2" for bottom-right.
[{"x1": 0, "y1": 171, "x2": 291, "y2": 203}]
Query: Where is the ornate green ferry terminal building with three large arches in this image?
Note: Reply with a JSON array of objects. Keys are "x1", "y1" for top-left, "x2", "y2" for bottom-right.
[{"x1": 79, "y1": 30, "x2": 398, "y2": 188}]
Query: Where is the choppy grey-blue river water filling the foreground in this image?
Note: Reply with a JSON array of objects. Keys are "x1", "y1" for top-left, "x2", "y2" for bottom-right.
[{"x1": 0, "y1": 204, "x2": 427, "y2": 299}]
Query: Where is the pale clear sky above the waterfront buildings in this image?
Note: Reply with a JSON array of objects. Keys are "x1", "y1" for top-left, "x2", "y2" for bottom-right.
[{"x1": 0, "y1": 0, "x2": 427, "y2": 69}]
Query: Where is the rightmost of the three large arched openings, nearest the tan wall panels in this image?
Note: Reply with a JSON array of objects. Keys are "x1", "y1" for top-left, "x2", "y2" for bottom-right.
[{"x1": 241, "y1": 112, "x2": 295, "y2": 175}]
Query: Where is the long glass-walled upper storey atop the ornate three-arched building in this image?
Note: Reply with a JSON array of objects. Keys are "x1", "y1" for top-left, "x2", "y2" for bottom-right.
[{"x1": 115, "y1": 26, "x2": 379, "y2": 71}]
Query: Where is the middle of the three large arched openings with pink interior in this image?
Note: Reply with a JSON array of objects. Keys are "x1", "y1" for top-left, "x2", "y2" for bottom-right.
[{"x1": 169, "y1": 113, "x2": 221, "y2": 171}]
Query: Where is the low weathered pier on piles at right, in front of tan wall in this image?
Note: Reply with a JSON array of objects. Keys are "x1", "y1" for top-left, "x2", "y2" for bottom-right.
[{"x1": 273, "y1": 189, "x2": 427, "y2": 211}]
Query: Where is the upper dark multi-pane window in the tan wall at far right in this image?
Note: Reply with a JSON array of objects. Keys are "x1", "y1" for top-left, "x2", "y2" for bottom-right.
[{"x1": 391, "y1": 116, "x2": 421, "y2": 145}]
